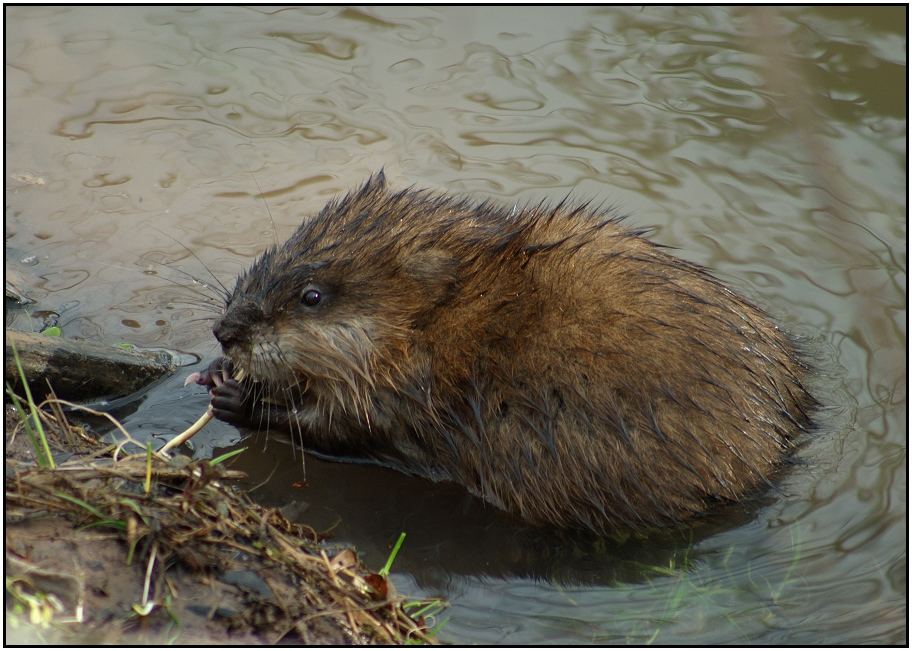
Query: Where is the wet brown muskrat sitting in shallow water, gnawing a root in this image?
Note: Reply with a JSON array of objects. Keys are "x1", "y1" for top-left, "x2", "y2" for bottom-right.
[{"x1": 200, "y1": 172, "x2": 814, "y2": 533}]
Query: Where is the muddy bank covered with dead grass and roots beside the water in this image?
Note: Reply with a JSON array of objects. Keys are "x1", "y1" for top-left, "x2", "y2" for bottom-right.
[{"x1": 4, "y1": 407, "x2": 442, "y2": 645}]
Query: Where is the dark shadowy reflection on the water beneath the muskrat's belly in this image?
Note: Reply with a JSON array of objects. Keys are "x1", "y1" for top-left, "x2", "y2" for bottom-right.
[{"x1": 219, "y1": 435, "x2": 773, "y2": 592}]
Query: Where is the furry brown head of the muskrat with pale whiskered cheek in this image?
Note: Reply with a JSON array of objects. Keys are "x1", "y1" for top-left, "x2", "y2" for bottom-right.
[{"x1": 213, "y1": 174, "x2": 456, "y2": 416}]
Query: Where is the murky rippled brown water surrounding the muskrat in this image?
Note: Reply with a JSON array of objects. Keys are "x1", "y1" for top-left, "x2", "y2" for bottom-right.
[{"x1": 5, "y1": 7, "x2": 908, "y2": 644}]
